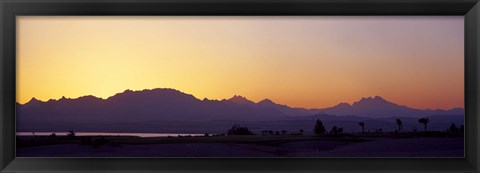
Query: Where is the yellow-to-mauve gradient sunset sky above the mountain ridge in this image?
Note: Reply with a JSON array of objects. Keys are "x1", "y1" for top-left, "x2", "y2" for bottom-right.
[{"x1": 17, "y1": 16, "x2": 464, "y2": 109}]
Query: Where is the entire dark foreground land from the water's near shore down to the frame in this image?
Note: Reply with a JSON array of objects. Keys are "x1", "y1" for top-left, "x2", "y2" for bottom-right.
[{"x1": 17, "y1": 135, "x2": 464, "y2": 157}]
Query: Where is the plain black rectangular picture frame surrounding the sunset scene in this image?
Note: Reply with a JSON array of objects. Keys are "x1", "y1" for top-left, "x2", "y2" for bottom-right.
[{"x1": 0, "y1": 0, "x2": 480, "y2": 173}]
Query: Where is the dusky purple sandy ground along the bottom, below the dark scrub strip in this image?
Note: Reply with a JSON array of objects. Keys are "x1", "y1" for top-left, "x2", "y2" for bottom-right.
[{"x1": 17, "y1": 138, "x2": 464, "y2": 157}]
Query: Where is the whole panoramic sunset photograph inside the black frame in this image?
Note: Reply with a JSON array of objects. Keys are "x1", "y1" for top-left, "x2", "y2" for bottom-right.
[{"x1": 16, "y1": 16, "x2": 465, "y2": 158}]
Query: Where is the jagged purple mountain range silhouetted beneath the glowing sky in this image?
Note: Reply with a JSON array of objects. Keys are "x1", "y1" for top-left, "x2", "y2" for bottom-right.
[{"x1": 17, "y1": 88, "x2": 464, "y2": 124}]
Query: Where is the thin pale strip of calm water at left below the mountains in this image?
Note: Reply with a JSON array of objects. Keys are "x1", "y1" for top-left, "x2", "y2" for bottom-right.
[{"x1": 16, "y1": 132, "x2": 204, "y2": 137}]
